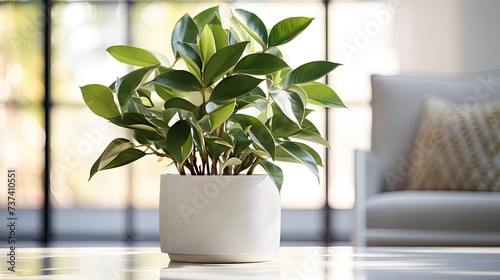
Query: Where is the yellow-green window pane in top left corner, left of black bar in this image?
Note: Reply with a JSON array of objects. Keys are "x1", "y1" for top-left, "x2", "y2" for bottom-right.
[{"x1": 0, "y1": 3, "x2": 44, "y2": 103}]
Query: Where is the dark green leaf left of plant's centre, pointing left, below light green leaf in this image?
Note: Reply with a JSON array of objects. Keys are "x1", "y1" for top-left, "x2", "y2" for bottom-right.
[{"x1": 153, "y1": 70, "x2": 201, "y2": 92}]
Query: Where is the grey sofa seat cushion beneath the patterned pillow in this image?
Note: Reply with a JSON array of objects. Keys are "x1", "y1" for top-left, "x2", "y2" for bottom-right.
[{"x1": 366, "y1": 191, "x2": 500, "y2": 232}]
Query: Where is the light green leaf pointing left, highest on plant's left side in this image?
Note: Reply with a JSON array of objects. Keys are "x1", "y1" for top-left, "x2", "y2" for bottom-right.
[{"x1": 106, "y1": 46, "x2": 160, "y2": 67}]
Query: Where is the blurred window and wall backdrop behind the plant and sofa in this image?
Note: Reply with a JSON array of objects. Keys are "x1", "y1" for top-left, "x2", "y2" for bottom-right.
[{"x1": 0, "y1": 0, "x2": 500, "y2": 246}]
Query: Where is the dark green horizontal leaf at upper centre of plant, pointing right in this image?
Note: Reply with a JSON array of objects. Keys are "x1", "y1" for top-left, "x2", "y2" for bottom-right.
[{"x1": 233, "y1": 53, "x2": 289, "y2": 75}]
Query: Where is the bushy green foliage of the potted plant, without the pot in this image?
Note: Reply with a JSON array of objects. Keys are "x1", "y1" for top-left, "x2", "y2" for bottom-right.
[{"x1": 81, "y1": 6, "x2": 345, "y2": 189}]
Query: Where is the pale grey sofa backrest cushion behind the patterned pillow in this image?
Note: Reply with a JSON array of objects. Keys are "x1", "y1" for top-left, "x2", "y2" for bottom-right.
[{"x1": 371, "y1": 69, "x2": 500, "y2": 190}]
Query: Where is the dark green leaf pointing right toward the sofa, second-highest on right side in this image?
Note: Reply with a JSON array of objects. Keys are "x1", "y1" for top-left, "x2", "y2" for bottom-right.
[{"x1": 284, "y1": 61, "x2": 340, "y2": 88}]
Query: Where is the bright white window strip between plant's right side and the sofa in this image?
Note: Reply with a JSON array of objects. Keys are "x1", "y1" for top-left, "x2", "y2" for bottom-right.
[{"x1": 328, "y1": 2, "x2": 399, "y2": 208}]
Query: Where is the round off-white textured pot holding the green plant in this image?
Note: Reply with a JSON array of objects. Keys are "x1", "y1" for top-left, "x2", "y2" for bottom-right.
[{"x1": 159, "y1": 174, "x2": 281, "y2": 263}]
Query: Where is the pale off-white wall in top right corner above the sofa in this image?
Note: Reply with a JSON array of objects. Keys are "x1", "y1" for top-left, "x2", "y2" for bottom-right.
[{"x1": 394, "y1": 0, "x2": 500, "y2": 74}]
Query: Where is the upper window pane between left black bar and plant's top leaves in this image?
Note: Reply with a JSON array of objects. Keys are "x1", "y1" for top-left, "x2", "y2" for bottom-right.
[{"x1": 51, "y1": 2, "x2": 126, "y2": 103}]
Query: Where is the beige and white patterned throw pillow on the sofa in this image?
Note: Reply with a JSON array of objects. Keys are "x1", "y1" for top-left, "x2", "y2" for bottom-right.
[{"x1": 406, "y1": 96, "x2": 500, "y2": 191}]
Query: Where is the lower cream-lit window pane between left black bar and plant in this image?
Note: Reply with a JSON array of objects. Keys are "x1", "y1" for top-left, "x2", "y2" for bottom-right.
[{"x1": 51, "y1": 107, "x2": 130, "y2": 208}]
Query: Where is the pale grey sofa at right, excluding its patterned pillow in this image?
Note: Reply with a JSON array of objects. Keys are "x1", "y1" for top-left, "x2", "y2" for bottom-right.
[{"x1": 351, "y1": 70, "x2": 500, "y2": 246}]
